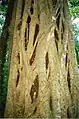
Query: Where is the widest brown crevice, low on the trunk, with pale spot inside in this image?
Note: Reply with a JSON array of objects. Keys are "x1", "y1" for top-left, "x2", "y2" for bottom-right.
[{"x1": 30, "y1": 75, "x2": 39, "y2": 103}]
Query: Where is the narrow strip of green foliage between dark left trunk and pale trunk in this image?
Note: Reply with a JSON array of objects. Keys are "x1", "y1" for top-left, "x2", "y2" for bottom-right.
[{"x1": 0, "y1": 39, "x2": 9, "y2": 117}]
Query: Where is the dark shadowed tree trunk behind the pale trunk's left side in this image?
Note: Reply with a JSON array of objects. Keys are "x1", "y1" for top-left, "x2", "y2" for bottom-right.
[{"x1": 0, "y1": 0, "x2": 15, "y2": 117}]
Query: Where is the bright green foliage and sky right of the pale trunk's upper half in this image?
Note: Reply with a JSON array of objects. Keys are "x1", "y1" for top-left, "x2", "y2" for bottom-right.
[{"x1": 69, "y1": 0, "x2": 79, "y2": 66}]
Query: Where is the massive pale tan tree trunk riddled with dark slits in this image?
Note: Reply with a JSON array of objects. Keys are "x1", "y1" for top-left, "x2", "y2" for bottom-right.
[{"x1": 5, "y1": 0, "x2": 79, "y2": 118}]
